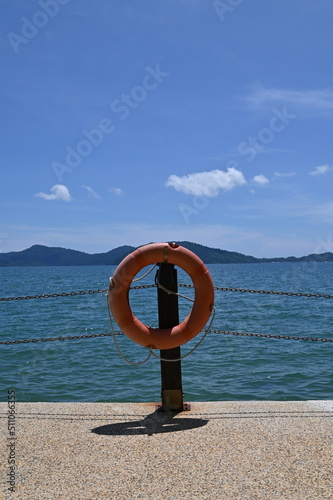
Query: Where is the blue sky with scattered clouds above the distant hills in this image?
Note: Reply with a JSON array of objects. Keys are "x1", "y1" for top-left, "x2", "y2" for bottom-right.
[{"x1": 0, "y1": 0, "x2": 333, "y2": 257}]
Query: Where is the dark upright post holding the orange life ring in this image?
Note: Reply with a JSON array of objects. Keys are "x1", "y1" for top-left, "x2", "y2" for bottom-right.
[{"x1": 157, "y1": 262, "x2": 183, "y2": 411}]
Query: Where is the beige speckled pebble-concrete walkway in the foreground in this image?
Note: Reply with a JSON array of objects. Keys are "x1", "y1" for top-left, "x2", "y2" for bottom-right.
[{"x1": 0, "y1": 401, "x2": 333, "y2": 500}]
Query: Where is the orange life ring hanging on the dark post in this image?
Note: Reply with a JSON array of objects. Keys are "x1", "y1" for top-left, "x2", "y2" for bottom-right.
[{"x1": 108, "y1": 243, "x2": 214, "y2": 349}]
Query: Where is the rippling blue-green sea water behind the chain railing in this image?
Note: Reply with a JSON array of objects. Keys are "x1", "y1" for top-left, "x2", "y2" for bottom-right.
[{"x1": 0, "y1": 263, "x2": 333, "y2": 402}]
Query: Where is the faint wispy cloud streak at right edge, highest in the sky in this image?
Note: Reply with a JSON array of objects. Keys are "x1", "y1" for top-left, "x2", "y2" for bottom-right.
[{"x1": 246, "y1": 84, "x2": 333, "y2": 110}]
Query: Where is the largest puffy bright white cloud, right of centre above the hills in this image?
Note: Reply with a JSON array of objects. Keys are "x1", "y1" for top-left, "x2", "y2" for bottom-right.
[{"x1": 165, "y1": 167, "x2": 246, "y2": 198}]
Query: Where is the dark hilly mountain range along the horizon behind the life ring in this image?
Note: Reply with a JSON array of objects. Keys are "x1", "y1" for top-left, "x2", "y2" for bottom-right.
[{"x1": 0, "y1": 241, "x2": 333, "y2": 267}]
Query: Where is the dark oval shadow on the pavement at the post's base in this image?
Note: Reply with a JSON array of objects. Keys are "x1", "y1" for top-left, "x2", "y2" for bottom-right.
[{"x1": 91, "y1": 410, "x2": 208, "y2": 436}]
